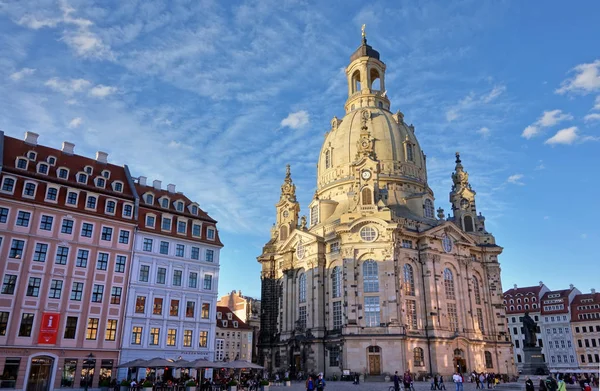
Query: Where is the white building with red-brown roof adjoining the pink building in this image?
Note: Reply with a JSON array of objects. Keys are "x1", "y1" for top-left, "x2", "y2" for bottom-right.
[{"x1": 119, "y1": 181, "x2": 222, "y2": 378}]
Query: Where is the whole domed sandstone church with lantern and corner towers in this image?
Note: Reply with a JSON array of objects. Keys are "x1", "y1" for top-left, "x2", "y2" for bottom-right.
[{"x1": 258, "y1": 35, "x2": 514, "y2": 376}]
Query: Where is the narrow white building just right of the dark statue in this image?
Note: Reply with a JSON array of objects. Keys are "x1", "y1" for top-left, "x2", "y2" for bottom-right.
[{"x1": 539, "y1": 285, "x2": 581, "y2": 373}]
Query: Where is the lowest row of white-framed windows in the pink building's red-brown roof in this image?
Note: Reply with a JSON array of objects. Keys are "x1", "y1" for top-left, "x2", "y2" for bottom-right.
[{"x1": 0, "y1": 176, "x2": 133, "y2": 218}]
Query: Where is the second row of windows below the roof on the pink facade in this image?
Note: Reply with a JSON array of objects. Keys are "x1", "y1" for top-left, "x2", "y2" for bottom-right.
[{"x1": 8, "y1": 239, "x2": 127, "y2": 273}]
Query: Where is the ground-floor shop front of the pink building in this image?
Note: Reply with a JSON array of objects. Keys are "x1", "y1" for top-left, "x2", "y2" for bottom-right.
[{"x1": 0, "y1": 348, "x2": 119, "y2": 391}]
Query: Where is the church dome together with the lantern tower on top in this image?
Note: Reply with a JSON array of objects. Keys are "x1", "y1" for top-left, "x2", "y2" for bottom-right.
[{"x1": 317, "y1": 38, "x2": 432, "y2": 205}]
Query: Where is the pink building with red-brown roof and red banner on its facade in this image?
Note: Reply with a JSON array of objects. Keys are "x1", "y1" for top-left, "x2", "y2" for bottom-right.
[{"x1": 0, "y1": 132, "x2": 136, "y2": 391}]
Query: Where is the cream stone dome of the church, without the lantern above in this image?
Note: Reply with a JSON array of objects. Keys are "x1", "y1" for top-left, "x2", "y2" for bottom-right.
[{"x1": 317, "y1": 107, "x2": 427, "y2": 196}]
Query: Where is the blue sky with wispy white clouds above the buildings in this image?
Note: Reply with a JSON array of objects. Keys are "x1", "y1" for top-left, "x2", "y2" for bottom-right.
[{"x1": 0, "y1": 0, "x2": 600, "y2": 296}]
